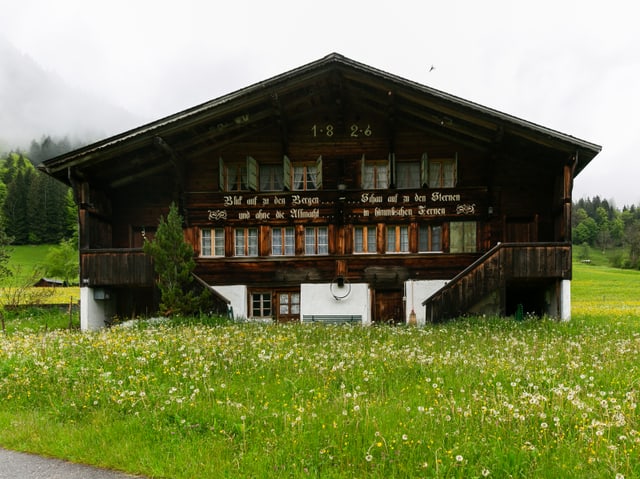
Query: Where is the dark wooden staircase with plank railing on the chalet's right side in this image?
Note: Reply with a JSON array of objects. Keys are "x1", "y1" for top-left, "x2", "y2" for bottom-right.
[{"x1": 422, "y1": 243, "x2": 571, "y2": 322}]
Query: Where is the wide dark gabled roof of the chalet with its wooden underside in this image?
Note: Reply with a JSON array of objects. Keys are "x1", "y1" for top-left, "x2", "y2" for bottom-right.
[{"x1": 40, "y1": 53, "x2": 601, "y2": 188}]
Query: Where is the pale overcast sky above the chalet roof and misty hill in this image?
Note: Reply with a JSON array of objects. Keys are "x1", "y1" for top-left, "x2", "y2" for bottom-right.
[{"x1": 0, "y1": 0, "x2": 640, "y2": 207}]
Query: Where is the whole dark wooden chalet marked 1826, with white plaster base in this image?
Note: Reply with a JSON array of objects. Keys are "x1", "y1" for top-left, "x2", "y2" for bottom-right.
[{"x1": 42, "y1": 54, "x2": 601, "y2": 329}]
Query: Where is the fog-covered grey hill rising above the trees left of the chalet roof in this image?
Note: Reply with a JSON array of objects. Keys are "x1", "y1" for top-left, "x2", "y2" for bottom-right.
[{"x1": 0, "y1": 35, "x2": 142, "y2": 152}]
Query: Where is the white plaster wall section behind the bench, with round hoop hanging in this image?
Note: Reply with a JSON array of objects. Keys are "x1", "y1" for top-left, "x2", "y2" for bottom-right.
[{"x1": 300, "y1": 283, "x2": 371, "y2": 324}]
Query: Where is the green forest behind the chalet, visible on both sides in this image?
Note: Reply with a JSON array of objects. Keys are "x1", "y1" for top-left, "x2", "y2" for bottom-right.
[{"x1": 0, "y1": 136, "x2": 640, "y2": 269}]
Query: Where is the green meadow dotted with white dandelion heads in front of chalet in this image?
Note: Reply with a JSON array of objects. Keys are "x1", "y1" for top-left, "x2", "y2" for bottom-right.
[{"x1": 0, "y1": 263, "x2": 640, "y2": 479}]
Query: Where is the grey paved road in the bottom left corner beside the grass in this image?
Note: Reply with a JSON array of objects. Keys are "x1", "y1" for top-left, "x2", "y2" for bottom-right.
[{"x1": 0, "y1": 449, "x2": 145, "y2": 479}]
